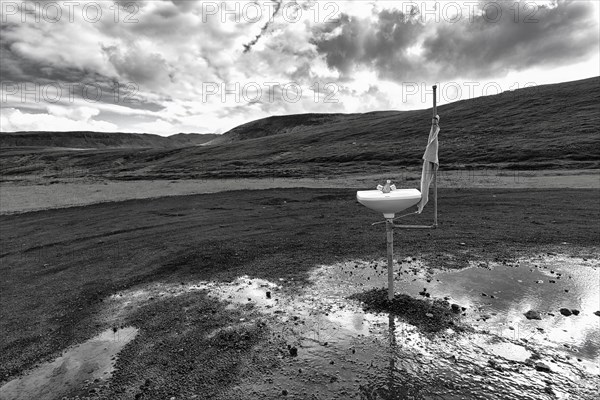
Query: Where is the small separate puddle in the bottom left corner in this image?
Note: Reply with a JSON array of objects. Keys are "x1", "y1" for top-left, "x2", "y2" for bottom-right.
[{"x1": 0, "y1": 327, "x2": 137, "y2": 400}]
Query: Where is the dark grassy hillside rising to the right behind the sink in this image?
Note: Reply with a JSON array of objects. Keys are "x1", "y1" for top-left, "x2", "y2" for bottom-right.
[{"x1": 1, "y1": 77, "x2": 600, "y2": 179}]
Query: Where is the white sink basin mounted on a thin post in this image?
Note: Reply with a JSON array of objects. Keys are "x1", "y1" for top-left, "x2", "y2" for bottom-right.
[{"x1": 356, "y1": 189, "x2": 421, "y2": 218}]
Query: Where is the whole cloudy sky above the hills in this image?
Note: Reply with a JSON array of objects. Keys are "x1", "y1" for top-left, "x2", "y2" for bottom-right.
[{"x1": 0, "y1": 0, "x2": 600, "y2": 135}]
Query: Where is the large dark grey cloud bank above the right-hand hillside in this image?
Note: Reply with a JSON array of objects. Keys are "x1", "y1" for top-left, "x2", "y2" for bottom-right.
[{"x1": 313, "y1": 0, "x2": 598, "y2": 81}]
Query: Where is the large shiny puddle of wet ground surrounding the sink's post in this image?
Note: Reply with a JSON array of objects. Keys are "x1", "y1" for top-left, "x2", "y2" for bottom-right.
[{"x1": 96, "y1": 255, "x2": 600, "y2": 399}]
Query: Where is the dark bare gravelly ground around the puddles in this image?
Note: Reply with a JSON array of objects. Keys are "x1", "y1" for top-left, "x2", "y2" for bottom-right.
[{"x1": 0, "y1": 189, "x2": 600, "y2": 399}]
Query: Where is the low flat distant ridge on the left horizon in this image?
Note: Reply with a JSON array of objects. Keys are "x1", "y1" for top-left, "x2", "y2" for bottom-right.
[{"x1": 0, "y1": 131, "x2": 217, "y2": 149}]
